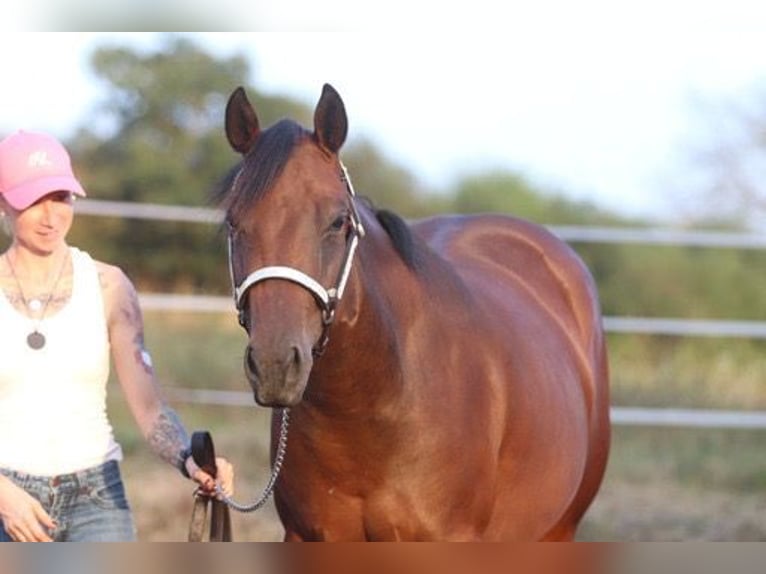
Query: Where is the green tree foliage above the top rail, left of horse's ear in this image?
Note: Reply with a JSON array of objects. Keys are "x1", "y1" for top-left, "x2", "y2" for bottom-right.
[{"x1": 77, "y1": 37, "x2": 247, "y2": 205}]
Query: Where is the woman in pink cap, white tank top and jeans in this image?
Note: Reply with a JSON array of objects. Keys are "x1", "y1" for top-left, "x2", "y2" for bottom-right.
[{"x1": 0, "y1": 131, "x2": 233, "y2": 541}]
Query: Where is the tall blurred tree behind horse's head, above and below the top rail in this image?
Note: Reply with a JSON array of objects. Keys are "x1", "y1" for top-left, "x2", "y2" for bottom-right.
[{"x1": 69, "y1": 35, "x2": 311, "y2": 292}]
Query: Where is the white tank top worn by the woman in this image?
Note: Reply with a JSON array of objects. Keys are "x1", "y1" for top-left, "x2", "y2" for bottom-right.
[{"x1": 0, "y1": 247, "x2": 122, "y2": 476}]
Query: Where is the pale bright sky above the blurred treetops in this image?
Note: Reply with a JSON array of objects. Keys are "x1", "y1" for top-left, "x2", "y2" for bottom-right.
[{"x1": 0, "y1": 9, "x2": 766, "y2": 217}]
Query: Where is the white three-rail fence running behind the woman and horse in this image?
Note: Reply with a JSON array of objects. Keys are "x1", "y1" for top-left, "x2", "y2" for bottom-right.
[{"x1": 75, "y1": 199, "x2": 766, "y2": 429}]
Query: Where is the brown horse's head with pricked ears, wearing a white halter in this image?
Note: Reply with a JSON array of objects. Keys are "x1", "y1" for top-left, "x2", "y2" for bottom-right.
[{"x1": 224, "y1": 85, "x2": 363, "y2": 406}]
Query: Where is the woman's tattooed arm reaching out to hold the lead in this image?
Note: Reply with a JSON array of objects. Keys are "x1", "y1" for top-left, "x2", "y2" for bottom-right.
[{"x1": 99, "y1": 264, "x2": 233, "y2": 493}]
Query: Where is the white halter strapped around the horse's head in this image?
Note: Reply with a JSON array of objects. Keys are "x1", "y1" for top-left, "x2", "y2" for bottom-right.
[{"x1": 228, "y1": 162, "x2": 364, "y2": 357}]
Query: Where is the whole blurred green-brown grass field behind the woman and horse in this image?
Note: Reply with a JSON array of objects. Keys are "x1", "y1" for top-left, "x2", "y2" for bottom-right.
[{"x1": 109, "y1": 312, "x2": 766, "y2": 541}]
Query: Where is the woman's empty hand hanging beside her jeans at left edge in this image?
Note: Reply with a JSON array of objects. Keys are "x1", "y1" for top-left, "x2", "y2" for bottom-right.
[{"x1": 0, "y1": 477, "x2": 56, "y2": 542}]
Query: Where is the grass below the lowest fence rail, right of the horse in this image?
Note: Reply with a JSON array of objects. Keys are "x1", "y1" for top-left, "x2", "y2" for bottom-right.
[{"x1": 578, "y1": 427, "x2": 766, "y2": 541}]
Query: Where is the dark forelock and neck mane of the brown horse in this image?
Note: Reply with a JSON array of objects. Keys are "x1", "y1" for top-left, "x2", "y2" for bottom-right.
[{"x1": 213, "y1": 119, "x2": 420, "y2": 270}]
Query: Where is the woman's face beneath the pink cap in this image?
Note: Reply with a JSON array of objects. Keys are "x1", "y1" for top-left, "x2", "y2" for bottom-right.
[{"x1": 3, "y1": 191, "x2": 74, "y2": 255}]
